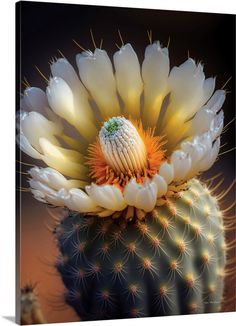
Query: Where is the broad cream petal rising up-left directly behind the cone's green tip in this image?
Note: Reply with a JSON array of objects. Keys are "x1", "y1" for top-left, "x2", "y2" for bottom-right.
[{"x1": 76, "y1": 49, "x2": 120, "y2": 118}]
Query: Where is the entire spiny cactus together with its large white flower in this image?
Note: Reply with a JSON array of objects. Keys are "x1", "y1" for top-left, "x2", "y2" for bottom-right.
[{"x1": 17, "y1": 33, "x2": 235, "y2": 320}]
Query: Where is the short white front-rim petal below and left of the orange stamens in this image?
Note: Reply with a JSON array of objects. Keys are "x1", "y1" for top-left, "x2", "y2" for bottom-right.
[{"x1": 65, "y1": 188, "x2": 99, "y2": 213}]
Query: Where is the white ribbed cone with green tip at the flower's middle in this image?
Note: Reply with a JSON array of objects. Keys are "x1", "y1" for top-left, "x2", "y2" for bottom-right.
[{"x1": 99, "y1": 117, "x2": 147, "y2": 174}]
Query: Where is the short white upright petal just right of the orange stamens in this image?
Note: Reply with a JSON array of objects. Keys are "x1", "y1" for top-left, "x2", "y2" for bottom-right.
[{"x1": 171, "y1": 150, "x2": 191, "y2": 181}]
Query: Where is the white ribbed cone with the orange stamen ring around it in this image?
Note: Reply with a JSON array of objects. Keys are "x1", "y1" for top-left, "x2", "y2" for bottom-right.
[{"x1": 86, "y1": 117, "x2": 165, "y2": 189}]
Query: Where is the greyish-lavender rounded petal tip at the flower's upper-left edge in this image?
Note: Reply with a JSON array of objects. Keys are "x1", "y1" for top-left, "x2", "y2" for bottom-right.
[{"x1": 23, "y1": 87, "x2": 48, "y2": 112}]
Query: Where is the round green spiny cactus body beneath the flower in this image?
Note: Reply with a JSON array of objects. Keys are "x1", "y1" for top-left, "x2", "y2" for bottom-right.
[{"x1": 55, "y1": 180, "x2": 225, "y2": 320}]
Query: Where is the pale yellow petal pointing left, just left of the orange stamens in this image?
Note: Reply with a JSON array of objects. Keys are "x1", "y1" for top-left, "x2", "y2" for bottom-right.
[{"x1": 39, "y1": 138, "x2": 88, "y2": 181}]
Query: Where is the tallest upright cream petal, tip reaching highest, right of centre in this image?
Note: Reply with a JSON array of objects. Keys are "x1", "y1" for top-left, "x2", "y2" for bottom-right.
[{"x1": 142, "y1": 41, "x2": 170, "y2": 127}]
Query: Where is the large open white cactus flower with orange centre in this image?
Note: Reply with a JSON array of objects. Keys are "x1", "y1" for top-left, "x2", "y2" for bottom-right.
[{"x1": 17, "y1": 41, "x2": 225, "y2": 219}]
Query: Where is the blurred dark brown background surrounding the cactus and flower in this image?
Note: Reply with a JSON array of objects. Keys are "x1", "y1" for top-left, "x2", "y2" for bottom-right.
[{"x1": 16, "y1": 2, "x2": 235, "y2": 322}]
